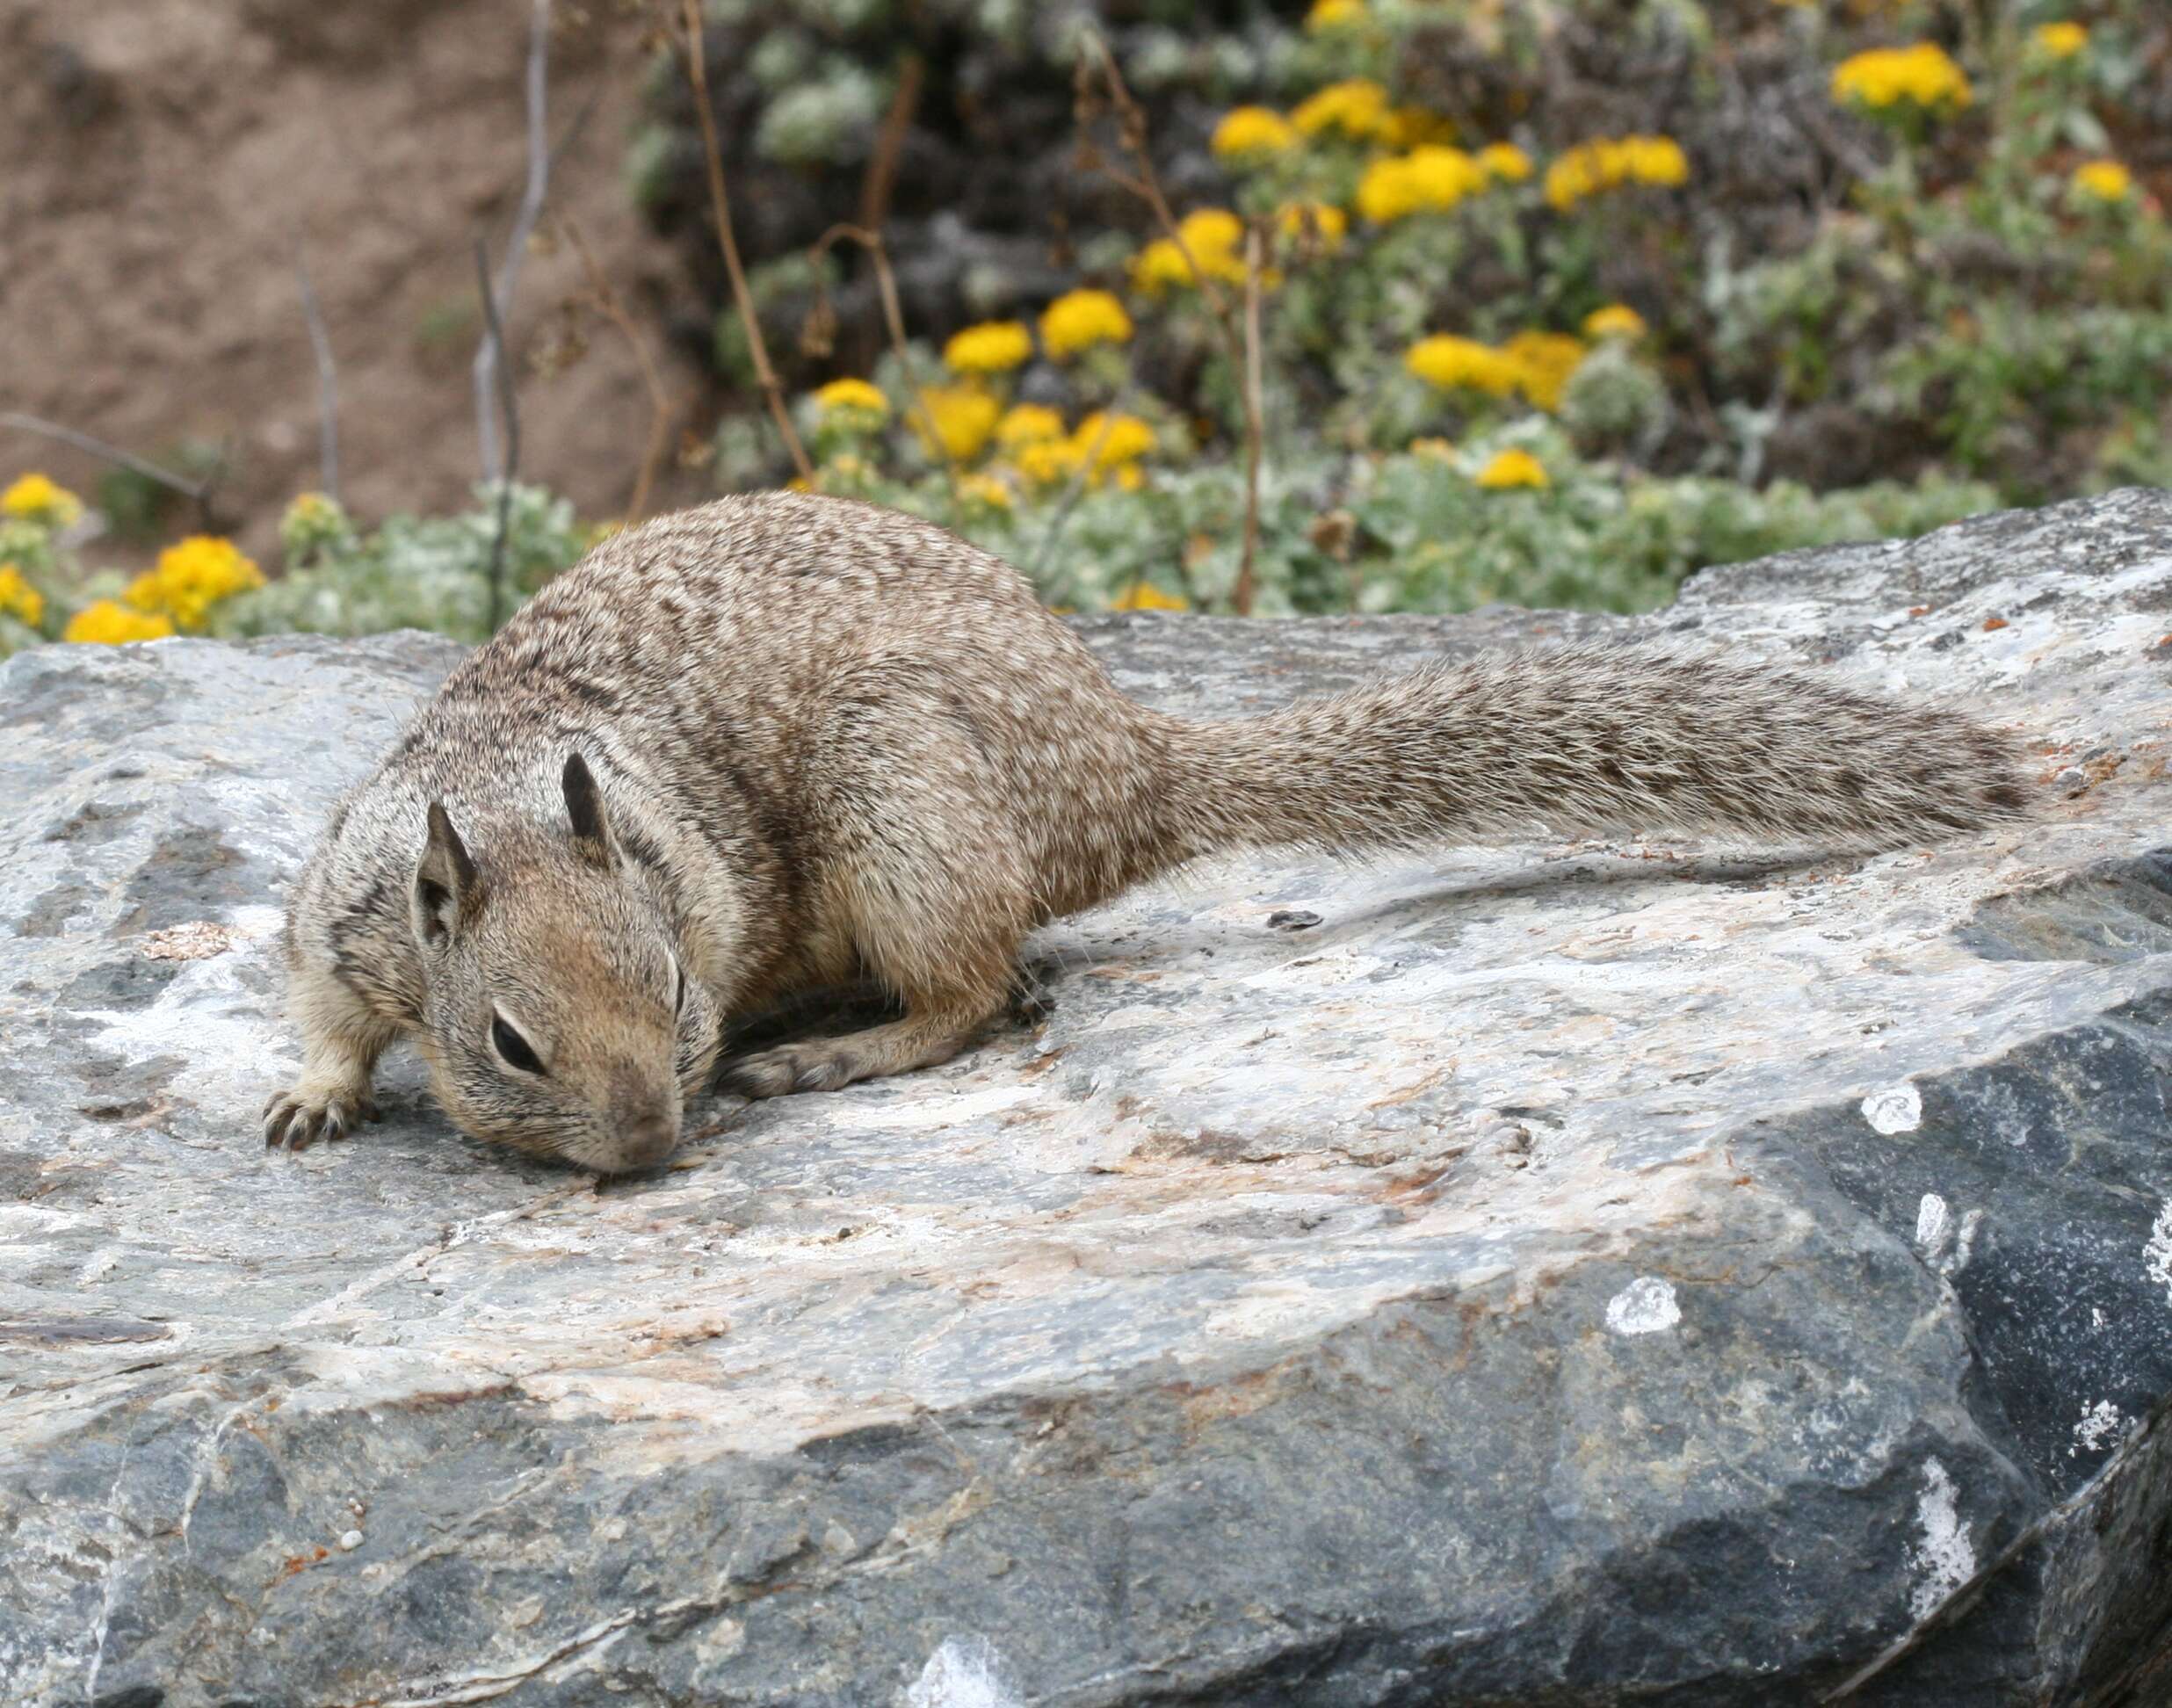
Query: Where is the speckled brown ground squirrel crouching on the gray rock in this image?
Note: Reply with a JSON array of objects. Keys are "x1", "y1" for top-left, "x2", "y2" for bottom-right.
[{"x1": 265, "y1": 493, "x2": 2024, "y2": 1171}]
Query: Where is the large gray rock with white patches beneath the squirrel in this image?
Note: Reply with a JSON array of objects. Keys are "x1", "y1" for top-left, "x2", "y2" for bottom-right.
[{"x1": 0, "y1": 493, "x2": 2172, "y2": 1708}]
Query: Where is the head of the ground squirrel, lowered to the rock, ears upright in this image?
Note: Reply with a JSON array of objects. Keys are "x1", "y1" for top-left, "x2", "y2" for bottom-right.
[{"x1": 410, "y1": 754, "x2": 721, "y2": 1174}]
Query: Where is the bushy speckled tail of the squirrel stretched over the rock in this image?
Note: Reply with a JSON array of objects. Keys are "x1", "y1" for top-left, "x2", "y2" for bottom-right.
[{"x1": 1166, "y1": 646, "x2": 2029, "y2": 858}]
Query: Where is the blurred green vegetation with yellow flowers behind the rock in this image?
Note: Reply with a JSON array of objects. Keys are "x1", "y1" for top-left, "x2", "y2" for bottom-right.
[{"x1": 0, "y1": 0, "x2": 2172, "y2": 648}]
